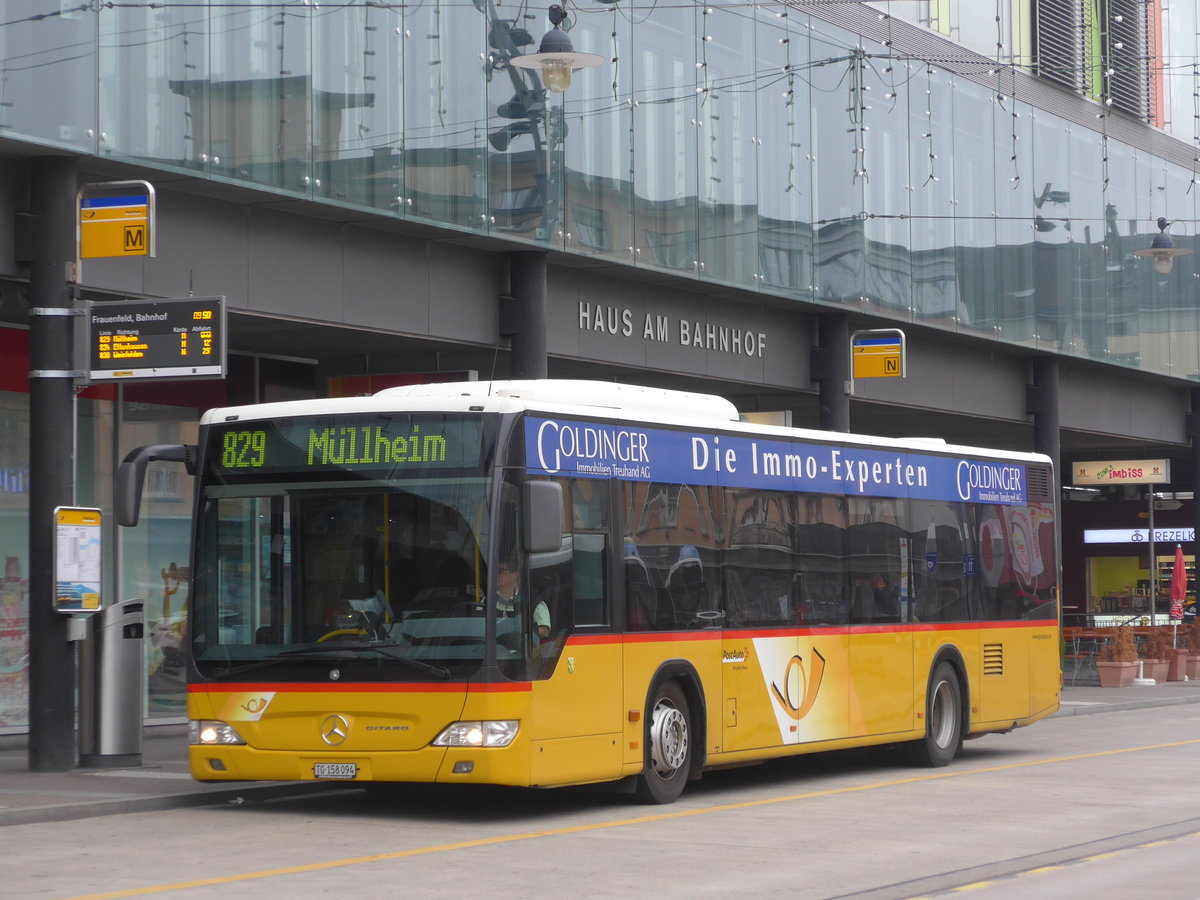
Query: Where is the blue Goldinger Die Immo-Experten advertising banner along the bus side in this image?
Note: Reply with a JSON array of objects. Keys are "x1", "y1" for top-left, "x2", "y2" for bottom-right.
[{"x1": 524, "y1": 416, "x2": 1027, "y2": 505}]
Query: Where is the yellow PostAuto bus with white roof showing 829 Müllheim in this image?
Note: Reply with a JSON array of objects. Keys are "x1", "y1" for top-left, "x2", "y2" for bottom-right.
[{"x1": 118, "y1": 380, "x2": 1061, "y2": 803}]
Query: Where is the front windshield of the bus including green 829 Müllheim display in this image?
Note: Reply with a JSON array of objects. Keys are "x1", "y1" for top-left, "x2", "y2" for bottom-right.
[{"x1": 190, "y1": 415, "x2": 501, "y2": 682}]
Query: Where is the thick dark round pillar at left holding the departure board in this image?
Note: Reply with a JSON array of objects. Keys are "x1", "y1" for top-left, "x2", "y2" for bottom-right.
[{"x1": 29, "y1": 156, "x2": 76, "y2": 772}]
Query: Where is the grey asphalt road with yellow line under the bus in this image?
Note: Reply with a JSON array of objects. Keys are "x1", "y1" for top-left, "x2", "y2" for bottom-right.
[{"x1": 9, "y1": 704, "x2": 1200, "y2": 900}]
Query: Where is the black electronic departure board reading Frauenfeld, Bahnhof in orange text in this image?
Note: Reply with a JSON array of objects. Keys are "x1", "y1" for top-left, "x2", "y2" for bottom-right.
[{"x1": 83, "y1": 296, "x2": 226, "y2": 382}]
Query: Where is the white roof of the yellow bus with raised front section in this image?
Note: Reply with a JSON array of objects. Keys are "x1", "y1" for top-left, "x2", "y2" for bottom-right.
[{"x1": 202, "y1": 378, "x2": 1050, "y2": 462}]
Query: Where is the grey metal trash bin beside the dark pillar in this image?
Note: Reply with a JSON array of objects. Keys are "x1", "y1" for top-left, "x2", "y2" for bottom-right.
[{"x1": 79, "y1": 600, "x2": 144, "y2": 768}]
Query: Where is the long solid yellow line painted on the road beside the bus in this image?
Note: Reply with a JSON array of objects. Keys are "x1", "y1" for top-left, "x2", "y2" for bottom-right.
[{"x1": 67, "y1": 738, "x2": 1200, "y2": 900}]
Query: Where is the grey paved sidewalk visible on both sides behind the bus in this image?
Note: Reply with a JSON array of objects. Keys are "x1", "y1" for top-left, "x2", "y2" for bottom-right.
[{"x1": 0, "y1": 682, "x2": 1200, "y2": 826}]
